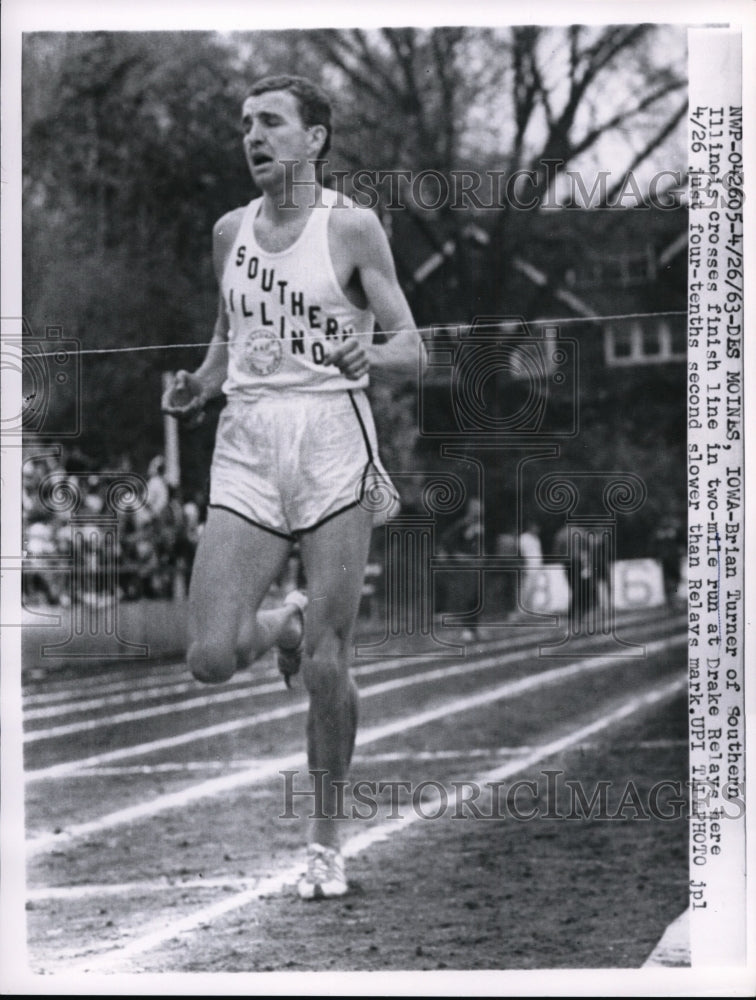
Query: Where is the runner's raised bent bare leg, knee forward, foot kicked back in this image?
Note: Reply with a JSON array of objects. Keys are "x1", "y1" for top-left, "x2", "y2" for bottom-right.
[{"x1": 188, "y1": 507, "x2": 297, "y2": 684}]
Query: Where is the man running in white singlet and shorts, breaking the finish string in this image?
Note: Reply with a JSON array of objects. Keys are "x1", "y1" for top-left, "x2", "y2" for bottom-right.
[{"x1": 163, "y1": 77, "x2": 423, "y2": 899}]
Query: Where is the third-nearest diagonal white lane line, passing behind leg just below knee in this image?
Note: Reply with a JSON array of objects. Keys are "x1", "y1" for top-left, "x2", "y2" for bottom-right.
[{"x1": 26, "y1": 637, "x2": 682, "y2": 781}]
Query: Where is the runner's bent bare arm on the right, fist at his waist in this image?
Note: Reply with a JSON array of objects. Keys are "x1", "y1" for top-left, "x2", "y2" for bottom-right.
[{"x1": 330, "y1": 209, "x2": 425, "y2": 379}]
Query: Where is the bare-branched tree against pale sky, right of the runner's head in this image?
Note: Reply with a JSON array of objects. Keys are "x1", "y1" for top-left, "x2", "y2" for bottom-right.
[{"x1": 280, "y1": 24, "x2": 687, "y2": 323}]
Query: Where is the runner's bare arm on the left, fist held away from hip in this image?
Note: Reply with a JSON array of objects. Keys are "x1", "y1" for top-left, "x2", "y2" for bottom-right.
[{"x1": 162, "y1": 209, "x2": 243, "y2": 419}]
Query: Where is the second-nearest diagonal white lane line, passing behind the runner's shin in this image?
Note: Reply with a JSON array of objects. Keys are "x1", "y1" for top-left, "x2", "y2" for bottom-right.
[{"x1": 27, "y1": 635, "x2": 688, "y2": 856}]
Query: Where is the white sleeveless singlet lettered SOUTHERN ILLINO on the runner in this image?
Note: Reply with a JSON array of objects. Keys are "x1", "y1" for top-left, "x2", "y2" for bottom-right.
[{"x1": 222, "y1": 188, "x2": 375, "y2": 400}]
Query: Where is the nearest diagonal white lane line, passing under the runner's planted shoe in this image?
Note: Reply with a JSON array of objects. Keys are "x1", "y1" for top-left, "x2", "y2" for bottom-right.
[{"x1": 59, "y1": 674, "x2": 687, "y2": 973}]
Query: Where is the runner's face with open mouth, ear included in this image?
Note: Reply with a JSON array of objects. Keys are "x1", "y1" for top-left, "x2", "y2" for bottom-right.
[{"x1": 242, "y1": 90, "x2": 318, "y2": 190}]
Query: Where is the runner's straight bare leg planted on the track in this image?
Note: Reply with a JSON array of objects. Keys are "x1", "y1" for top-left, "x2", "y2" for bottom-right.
[{"x1": 300, "y1": 507, "x2": 372, "y2": 847}]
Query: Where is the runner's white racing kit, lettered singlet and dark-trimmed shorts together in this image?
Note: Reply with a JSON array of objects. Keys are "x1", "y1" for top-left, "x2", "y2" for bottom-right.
[{"x1": 209, "y1": 189, "x2": 398, "y2": 539}]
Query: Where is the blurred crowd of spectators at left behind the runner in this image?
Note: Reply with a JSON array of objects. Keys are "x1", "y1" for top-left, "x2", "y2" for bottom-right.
[{"x1": 22, "y1": 447, "x2": 205, "y2": 607}]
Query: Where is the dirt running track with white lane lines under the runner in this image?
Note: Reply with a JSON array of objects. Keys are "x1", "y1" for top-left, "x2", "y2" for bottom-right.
[{"x1": 17, "y1": 612, "x2": 688, "y2": 980}]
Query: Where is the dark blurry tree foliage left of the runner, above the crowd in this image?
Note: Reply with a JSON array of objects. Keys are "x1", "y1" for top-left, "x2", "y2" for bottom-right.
[{"x1": 23, "y1": 32, "x2": 249, "y2": 466}]
